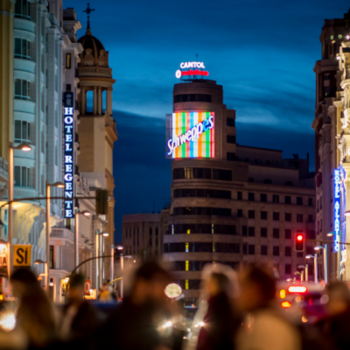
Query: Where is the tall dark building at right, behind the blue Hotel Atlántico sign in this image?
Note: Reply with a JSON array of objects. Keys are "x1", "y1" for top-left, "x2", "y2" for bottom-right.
[{"x1": 312, "y1": 8, "x2": 350, "y2": 280}]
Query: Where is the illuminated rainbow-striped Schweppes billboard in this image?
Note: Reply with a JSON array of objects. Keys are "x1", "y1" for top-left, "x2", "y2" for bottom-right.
[{"x1": 166, "y1": 111, "x2": 215, "y2": 159}]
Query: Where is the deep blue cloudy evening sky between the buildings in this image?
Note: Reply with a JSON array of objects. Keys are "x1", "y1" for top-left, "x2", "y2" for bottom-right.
[{"x1": 69, "y1": 0, "x2": 349, "y2": 241}]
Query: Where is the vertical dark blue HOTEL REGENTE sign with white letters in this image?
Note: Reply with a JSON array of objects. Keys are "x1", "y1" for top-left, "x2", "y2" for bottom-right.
[{"x1": 63, "y1": 92, "x2": 74, "y2": 219}]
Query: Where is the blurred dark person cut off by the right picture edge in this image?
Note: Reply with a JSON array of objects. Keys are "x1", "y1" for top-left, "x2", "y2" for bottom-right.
[{"x1": 317, "y1": 282, "x2": 350, "y2": 350}]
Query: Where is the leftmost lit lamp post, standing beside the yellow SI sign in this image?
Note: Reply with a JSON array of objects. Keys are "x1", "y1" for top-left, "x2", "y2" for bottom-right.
[{"x1": 7, "y1": 143, "x2": 32, "y2": 284}]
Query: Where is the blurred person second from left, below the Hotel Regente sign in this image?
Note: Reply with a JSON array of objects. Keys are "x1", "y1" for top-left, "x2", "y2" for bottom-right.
[{"x1": 60, "y1": 274, "x2": 99, "y2": 341}]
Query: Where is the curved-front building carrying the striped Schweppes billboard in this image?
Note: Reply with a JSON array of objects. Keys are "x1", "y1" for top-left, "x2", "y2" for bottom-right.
[{"x1": 164, "y1": 79, "x2": 315, "y2": 305}]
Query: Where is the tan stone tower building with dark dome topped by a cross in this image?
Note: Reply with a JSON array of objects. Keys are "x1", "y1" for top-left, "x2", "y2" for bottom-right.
[{"x1": 78, "y1": 7, "x2": 118, "y2": 281}]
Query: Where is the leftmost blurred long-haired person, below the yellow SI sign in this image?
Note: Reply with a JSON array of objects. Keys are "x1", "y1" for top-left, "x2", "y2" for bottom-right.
[{"x1": 10, "y1": 269, "x2": 56, "y2": 349}]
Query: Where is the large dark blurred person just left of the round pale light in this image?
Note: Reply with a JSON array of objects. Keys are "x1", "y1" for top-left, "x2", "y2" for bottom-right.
[{"x1": 96, "y1": 262, "x2": 171, "y2": 350}]
